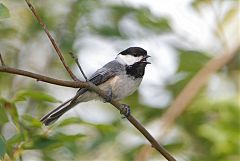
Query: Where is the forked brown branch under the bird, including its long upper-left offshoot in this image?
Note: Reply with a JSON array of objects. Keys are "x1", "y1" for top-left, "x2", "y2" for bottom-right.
[{"x1": 0, "y1": 0, "x2": 176, "y2": 161}]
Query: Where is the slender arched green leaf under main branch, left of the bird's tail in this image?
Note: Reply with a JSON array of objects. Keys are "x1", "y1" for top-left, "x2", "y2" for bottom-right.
[{"x1": 13, "y1": 90, "x2": 59, "y2": 103}]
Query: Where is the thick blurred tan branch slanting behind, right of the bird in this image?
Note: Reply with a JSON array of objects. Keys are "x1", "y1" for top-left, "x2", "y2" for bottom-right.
[{"x1": 135, "y1": 46, "x2": 240, "y2": 161}]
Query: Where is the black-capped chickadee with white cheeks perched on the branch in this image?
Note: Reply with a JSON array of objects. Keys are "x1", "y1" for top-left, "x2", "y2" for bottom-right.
[{"x1": 40, "y1": 47, "x2": 151, "y2": 126}]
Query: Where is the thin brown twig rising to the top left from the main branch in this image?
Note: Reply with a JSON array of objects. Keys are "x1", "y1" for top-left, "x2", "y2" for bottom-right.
[{"x1": 25, "y1": 0, "x2": 79, "y2": 81}]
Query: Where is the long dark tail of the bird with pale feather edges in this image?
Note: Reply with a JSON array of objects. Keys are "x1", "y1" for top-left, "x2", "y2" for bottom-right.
[{"x1": 40, "y1": 97, "x2": 77, "y2": 126}]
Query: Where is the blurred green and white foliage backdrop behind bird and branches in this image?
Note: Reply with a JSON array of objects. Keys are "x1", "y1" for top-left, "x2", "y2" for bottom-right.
[{"x1": 0, "y1": 0, "x2": 240, "y2": 161}]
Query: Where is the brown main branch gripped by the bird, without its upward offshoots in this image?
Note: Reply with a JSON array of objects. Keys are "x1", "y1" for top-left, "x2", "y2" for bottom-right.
[{"x1": 0, "y1": 66, "x2": 175, "y2": 161}]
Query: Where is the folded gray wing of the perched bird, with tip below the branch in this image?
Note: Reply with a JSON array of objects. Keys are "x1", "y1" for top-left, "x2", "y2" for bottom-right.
[{"x1": 73, "y1": 60, "x2": 125, "y2": 98}]
